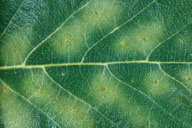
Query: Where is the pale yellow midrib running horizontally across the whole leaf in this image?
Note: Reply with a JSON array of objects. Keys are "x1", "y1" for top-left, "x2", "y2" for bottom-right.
[{"x1": 0, "y1": 60, "x2": 192, "y2": 70}]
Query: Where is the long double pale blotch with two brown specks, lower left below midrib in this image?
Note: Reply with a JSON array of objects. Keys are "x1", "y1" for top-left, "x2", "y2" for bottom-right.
[{"x1": 22, "y1": 72, "x2": 94, "y2": 128}]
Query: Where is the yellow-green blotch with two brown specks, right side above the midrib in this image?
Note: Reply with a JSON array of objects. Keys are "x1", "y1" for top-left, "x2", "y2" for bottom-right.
[{"x1": 113, "y1": 22, "x2": 165, "y2": 56}]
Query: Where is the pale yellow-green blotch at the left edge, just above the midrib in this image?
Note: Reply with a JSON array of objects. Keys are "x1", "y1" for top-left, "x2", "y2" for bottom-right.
[{"x1": 0, "y1": 25, "x2": 33, "y2": 65}]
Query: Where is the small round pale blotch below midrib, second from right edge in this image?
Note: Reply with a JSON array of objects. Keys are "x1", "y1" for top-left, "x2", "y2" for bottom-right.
[{"x1": 143, "y1": 70, "x2": 171, "y2": 96}]
